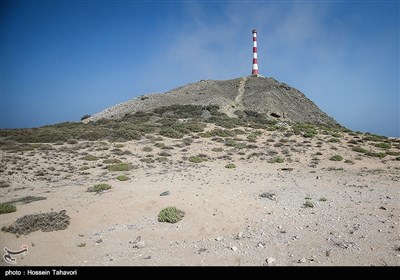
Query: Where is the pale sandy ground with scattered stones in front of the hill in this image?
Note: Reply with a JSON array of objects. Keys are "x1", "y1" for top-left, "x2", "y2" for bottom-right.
[{"x1": 0, "y1": 127, "x2": 400, "y2": 266}]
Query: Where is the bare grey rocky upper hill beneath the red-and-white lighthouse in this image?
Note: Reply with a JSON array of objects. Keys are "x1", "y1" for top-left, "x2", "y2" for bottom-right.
[{"x1": 84, "y1": 76, "x2": 340, "y2": 127}]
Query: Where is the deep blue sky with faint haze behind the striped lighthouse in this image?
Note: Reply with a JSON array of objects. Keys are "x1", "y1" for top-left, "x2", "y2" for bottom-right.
[{"x1": 0, "y1": 0, "x2": 400, "y2": 137}]
